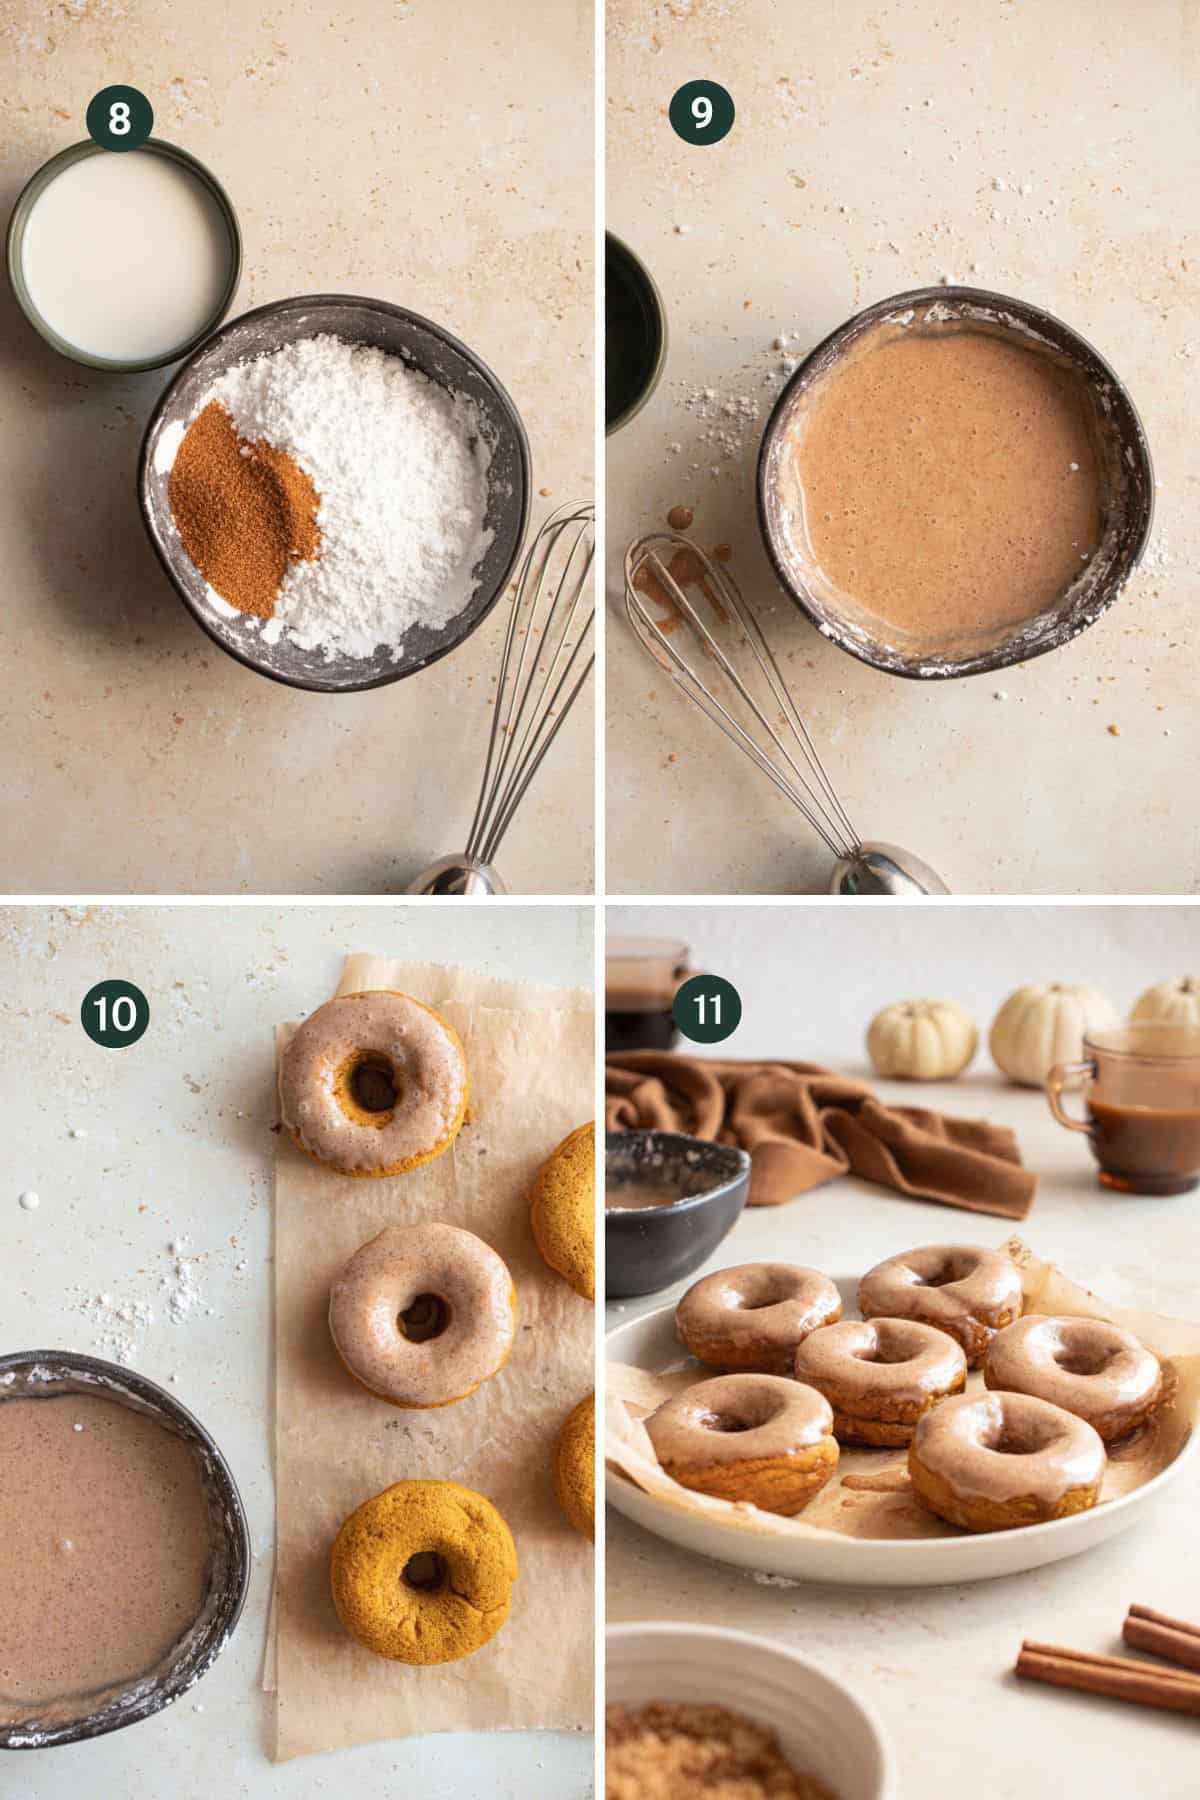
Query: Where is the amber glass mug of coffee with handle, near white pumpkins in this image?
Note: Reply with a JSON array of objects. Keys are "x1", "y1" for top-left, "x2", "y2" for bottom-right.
[{"x1": 1045, "y1": 1021, "x2": 1200, "y2": 1193}]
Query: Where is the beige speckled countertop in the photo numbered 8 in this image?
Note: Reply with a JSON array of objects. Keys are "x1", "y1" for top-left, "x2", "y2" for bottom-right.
[{"x1": 0, "y1": 0, "x2": 594, "y2": 895}]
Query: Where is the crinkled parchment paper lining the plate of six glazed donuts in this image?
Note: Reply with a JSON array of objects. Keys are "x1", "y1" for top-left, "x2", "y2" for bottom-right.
[{"x1": 604, "y1": 1237, "x2": 1200, "y2": 1539}]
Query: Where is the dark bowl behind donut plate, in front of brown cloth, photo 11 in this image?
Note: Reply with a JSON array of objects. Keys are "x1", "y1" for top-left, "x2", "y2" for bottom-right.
[{"x1": 604, "y1": 1130, "x2": 750, "y2": 1300}]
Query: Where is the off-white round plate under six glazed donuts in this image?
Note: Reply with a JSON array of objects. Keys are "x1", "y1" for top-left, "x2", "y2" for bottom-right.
[{"x1": 604, "y1": 1280, "x2": 1200, "y2": 1588}]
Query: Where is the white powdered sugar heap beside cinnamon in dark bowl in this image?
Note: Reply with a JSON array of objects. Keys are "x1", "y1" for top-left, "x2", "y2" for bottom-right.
[{"x1": 195, "y1": 335, "x2": 493, "y2": 661}]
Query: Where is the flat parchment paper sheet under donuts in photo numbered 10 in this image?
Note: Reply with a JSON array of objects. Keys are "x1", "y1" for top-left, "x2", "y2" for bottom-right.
[{"x1": 268, "y1": 956, "x2": 596, "y2": 1762}]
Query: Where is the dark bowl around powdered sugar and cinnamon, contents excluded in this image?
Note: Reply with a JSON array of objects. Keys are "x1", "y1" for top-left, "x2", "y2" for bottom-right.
[{"x1": 137, "y1": 293, "x2": 531, "y2": 693}]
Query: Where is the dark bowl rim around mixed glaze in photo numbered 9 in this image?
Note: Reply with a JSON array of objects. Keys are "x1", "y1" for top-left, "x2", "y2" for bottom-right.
[{"x1": 757, "y1": 286, "x2": 1155, "y2": 680}]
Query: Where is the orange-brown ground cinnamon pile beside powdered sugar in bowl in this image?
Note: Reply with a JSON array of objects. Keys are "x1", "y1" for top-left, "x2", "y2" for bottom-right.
[{"x1": 167, "y1": 400, "x2": 320, "y2": 619}]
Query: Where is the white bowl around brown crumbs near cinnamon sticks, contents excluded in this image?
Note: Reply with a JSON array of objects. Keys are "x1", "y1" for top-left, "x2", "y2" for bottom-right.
[{"x1": 604, "y1": 1624, "x2": 900, "y2": 1800}]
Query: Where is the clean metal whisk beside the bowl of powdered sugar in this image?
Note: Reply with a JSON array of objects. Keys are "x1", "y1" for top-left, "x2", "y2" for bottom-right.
[{"x1": 407, "y1": 500, "x2": 596, "y2": 895}]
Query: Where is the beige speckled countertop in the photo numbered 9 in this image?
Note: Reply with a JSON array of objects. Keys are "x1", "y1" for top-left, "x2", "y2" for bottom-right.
[{"x1": 608, "y1": 0, "x2": 1200, "y2": 895}]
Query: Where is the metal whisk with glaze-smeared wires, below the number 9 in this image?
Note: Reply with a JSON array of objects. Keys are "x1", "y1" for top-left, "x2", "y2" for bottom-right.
[{"x1": 624, "y1": 531, "x2": 950, "y2": 895}]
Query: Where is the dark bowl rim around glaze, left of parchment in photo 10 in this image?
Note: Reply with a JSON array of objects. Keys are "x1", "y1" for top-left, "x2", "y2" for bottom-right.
[{"x1": 0, "y1": 1350, "x2": 250, "y2": 1750}]
